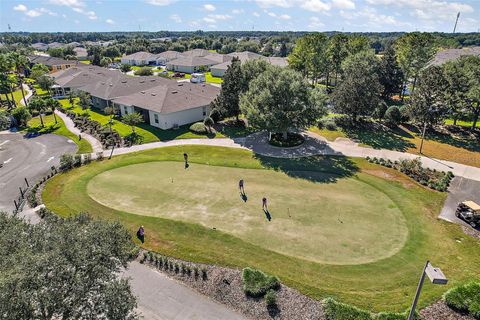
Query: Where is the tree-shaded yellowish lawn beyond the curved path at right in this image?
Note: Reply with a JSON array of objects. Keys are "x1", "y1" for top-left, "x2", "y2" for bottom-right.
[{"x1": 309, "y1": 121, "x2": 480, "y2": 167}]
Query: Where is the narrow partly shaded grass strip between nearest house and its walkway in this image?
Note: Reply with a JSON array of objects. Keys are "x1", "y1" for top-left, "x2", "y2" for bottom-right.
[{"x1": 59, "y1": 99, "x2": 225, "y2": 143}]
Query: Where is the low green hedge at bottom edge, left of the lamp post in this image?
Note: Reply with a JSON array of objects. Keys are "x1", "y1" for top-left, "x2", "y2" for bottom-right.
[{"x1": 323, "y1": 298, "x2": 420, "y2": 320}]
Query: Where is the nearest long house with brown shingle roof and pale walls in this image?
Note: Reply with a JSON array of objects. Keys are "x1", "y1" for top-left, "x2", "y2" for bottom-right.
[{"x1": 52, "y1": 66, "x2": 220, "y2": 130}]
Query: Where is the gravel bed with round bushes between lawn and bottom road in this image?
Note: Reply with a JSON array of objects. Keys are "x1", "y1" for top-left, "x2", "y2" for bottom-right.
[{"x1": 141, "y1": 254, "x2": 325, "y2": 320}]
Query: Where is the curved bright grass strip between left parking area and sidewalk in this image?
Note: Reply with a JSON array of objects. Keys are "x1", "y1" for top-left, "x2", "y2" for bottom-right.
[{"x1": 27, "y1": 114, "x2": 93, "y2": 154}]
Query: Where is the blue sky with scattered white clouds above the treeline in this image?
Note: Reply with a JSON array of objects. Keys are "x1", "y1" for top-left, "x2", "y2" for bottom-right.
[{"x1": 0, "y1": 0, "x2": 480, "y2": 32}]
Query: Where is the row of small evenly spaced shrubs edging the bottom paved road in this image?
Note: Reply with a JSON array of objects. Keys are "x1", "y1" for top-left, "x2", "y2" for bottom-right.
[{"x1": 140, "y1": 251, "x2": 208, "y2": 280}]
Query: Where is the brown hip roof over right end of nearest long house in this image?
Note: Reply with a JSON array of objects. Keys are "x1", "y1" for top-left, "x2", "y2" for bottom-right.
[{"x1": 112, "y1": 81, "x2": 220, "y2": 114}]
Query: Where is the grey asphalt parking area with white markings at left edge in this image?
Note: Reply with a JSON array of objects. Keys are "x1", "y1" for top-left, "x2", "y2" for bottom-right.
[{"x1": 0, "y1": 133, "x2": 77, "y2": 216}]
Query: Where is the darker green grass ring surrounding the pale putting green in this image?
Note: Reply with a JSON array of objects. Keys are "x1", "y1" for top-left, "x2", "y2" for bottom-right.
[{"x1": 43, "y1": 146, "x2": 480, "y2": 311}]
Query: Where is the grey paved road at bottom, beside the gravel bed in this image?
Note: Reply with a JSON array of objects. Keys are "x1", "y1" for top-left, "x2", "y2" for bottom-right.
[{"x1": 124, "y1": 261, "x2": 245, "y2": 320}]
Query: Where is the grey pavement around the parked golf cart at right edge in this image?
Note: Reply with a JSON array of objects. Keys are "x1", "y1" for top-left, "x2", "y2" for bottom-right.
[{"x1": 440, "y1": 177, "x2": 480, "y2": 226}]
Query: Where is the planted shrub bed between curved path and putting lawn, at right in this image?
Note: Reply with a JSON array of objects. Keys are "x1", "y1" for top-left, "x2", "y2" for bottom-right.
[{"x1": 366, "y1": 157, "x2": 454, "y2": 192}]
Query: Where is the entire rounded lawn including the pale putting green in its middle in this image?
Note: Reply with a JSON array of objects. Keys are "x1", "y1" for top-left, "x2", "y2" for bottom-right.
[{"x1": 43, "y1": 146, "x2": 480, "y2": 311}]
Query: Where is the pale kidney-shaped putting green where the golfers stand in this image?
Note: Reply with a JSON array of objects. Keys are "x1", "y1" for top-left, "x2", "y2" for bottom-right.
[{"x1": 87, "y1": 161, "x2": 408, "y2": 264}]
